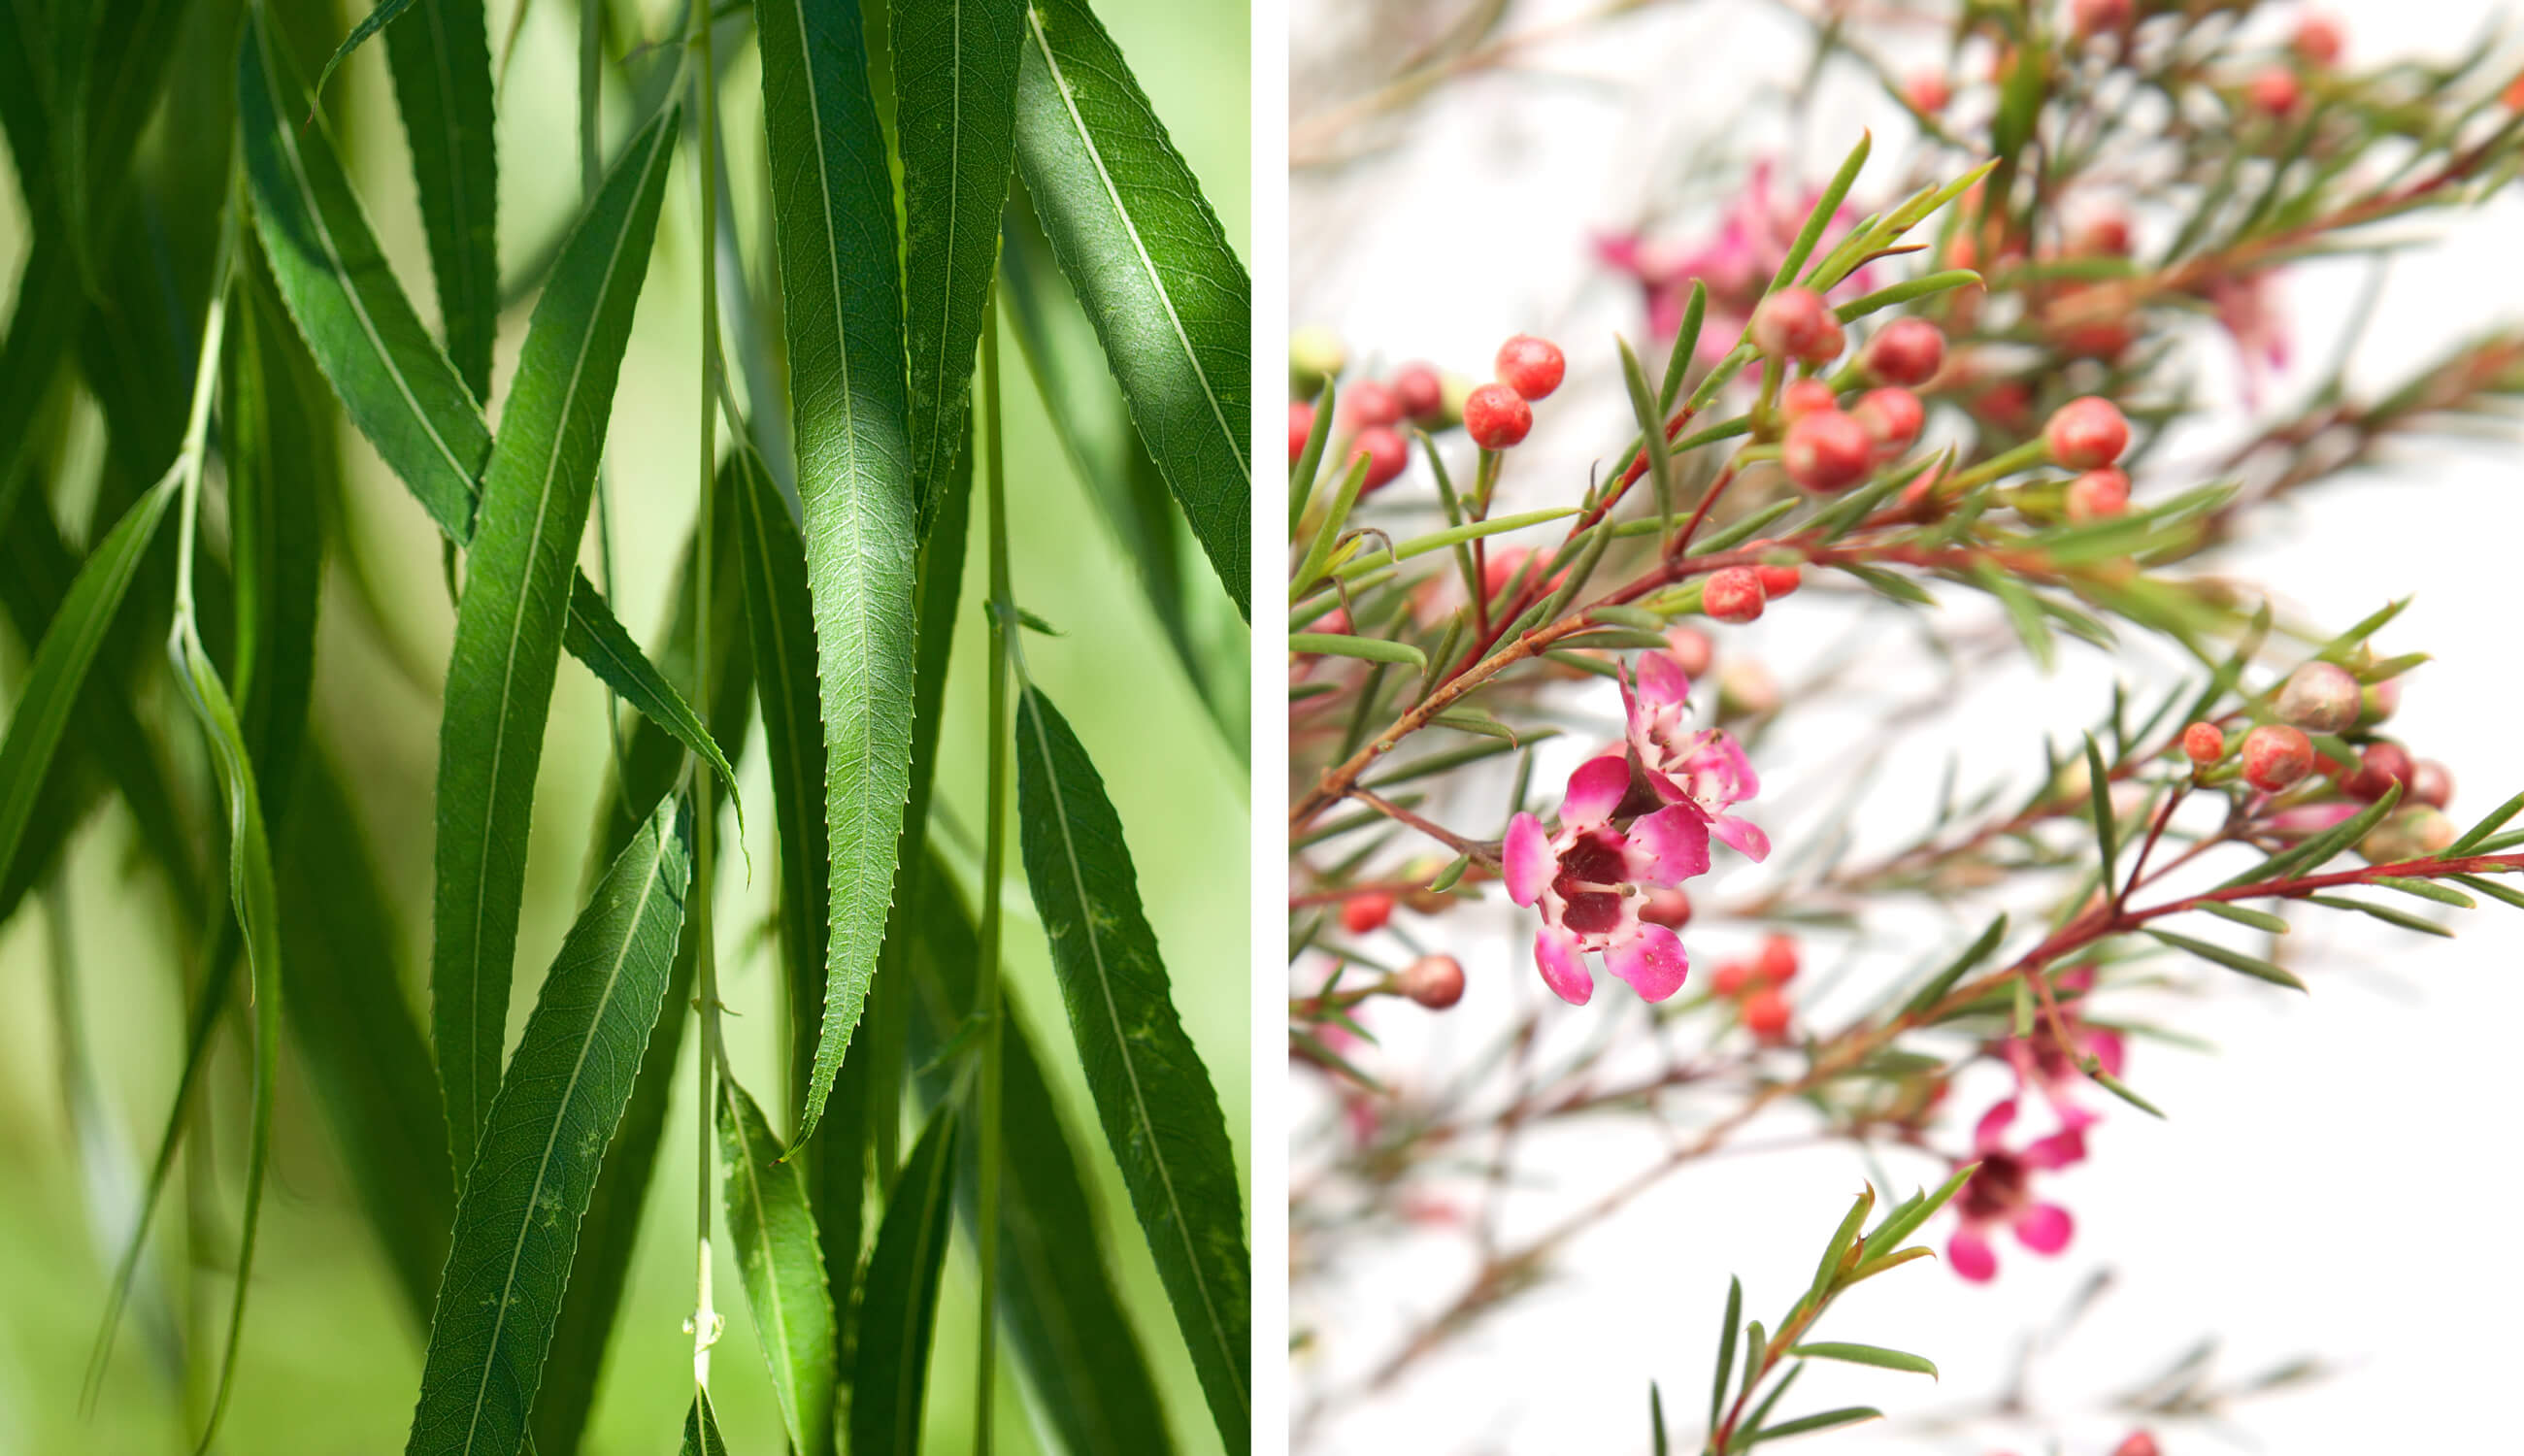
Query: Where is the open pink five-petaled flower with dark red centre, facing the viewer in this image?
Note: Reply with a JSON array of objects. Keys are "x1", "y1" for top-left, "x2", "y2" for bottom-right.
[{"x1": 1502, "y1": 754, "x2": 1709, "y2": 1007}]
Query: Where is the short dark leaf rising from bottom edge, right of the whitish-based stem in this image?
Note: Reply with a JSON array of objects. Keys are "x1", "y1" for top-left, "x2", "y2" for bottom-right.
[{"x1": 850, "y1": 1108, "x2": 956, "y2": 1456}]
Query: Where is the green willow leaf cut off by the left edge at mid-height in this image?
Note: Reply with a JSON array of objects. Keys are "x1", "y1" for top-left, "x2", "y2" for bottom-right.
[{"x1": 0, "y1": 477, "x2": 174, "y2": 878}]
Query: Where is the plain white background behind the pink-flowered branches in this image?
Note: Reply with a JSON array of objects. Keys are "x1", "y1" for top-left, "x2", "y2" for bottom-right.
[{"x1": 1292, "y1": 0, "x2": 2524, "y2": 1456}]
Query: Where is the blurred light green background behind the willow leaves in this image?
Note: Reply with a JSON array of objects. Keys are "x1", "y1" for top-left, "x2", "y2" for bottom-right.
[{"x1": 0, "y1": 0, "x2": 1252, "y2": 1453}]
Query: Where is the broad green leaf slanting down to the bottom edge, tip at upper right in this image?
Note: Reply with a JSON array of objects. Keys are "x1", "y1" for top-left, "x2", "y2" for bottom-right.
[{"x1": 404, "y1": 800, "x2": 691, "y2": 1456}]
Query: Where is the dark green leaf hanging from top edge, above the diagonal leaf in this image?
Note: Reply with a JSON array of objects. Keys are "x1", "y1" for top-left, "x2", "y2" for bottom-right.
[{"x1": 379, "y1": 0, "x2": 502, "y2": 399}]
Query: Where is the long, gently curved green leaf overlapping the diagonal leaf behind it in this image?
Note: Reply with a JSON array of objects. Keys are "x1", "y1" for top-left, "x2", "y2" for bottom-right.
[{"x1": 429, "y1": 111, "x2": 677, "y2": 1169}]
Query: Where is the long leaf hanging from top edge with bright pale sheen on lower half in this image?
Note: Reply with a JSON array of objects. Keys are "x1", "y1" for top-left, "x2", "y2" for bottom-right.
[{"x1": 754, "y1": 0, "x2": 913, "y2": 1143}]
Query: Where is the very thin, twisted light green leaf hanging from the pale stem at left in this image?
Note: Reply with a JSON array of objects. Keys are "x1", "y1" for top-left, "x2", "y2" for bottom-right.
[{"x1": 172, "y1": 631, "x2": 281, "y2": 1451}]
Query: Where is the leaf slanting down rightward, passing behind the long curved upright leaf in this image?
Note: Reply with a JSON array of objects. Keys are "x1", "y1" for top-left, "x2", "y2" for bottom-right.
[{"x1": 237, "y1": 8, "x2": 732, "y2": 778}]
